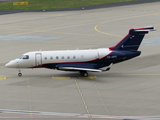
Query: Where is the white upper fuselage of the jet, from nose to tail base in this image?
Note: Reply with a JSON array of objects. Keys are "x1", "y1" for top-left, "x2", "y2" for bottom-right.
[{"x1": 6, "y1": 48, "x2": 112, "y2": 68}]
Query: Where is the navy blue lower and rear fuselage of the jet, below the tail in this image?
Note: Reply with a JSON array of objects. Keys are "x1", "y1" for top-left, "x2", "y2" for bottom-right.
[{"x1": 41, "y1": 50, "x2": 141, "y2": 69}]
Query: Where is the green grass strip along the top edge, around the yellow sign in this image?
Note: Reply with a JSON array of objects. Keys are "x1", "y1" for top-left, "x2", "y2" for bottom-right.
[{"x1": 0, "y1": 0, "x2": 136, "y2": 10}]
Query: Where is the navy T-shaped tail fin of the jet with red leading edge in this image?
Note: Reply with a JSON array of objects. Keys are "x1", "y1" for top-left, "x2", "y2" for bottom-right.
[{"x1": 109, "y1": 27, "x2": 154, "y2": 51}]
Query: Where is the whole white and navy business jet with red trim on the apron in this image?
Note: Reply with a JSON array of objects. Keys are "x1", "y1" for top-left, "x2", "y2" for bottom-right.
[{"x1": 5, "y1": 27, "x2": 154, "y2": 77}]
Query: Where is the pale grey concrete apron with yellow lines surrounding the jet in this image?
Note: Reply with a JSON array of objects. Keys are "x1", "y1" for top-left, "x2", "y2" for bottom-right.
[{"x1": 0, "y1": 2, "x2": 160, "y2": 120}]
